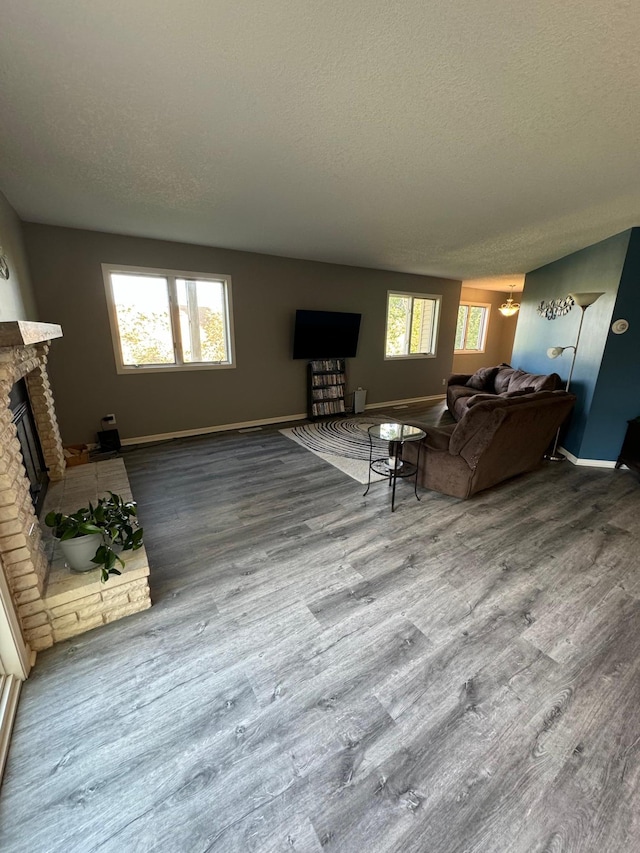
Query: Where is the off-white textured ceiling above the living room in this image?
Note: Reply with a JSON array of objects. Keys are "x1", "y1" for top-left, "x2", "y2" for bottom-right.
[{"x1": 0, "y1": 0, "x2": 640, "y2": 278}]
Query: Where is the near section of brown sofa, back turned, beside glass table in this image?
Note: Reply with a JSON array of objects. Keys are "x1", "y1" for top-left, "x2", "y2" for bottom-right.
[{"x1": 404, "y1": 391, "x2": 576, "y2": 498}]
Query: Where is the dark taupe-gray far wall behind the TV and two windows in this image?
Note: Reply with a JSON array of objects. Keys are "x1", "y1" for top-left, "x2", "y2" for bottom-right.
[{"x1": 24, "y1": 224, "x2": 460, "y2": 443}]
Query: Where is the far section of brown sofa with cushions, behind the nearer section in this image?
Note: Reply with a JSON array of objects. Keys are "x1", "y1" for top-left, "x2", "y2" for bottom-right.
[{"x1": 447, "y1": 364, "x2": 562, "y2": 421}]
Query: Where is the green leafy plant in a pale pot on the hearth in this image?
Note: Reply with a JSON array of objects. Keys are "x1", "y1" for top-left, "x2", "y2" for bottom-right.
[{"x1": 44, "y1": 492, "x2": 143, "y2": 583}]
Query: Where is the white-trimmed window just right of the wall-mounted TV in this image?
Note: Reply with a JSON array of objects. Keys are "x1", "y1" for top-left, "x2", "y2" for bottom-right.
[{"x1": 384, "y1": 290, "x2": 441, "y2": 358}]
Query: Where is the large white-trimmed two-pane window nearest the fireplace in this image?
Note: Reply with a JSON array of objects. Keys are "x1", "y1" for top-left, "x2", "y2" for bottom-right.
[{"x1": 102, "y1": 264, "x2": 234, "y2": 373}]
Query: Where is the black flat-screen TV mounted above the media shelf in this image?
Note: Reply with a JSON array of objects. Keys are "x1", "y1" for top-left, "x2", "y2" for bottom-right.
[{"x1": 293, "y1": 309, "x2": 362, "y2": 358}]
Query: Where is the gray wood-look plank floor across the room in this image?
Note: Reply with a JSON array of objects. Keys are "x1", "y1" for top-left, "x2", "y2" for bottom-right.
[{"x1": 0, "y1": 412, "x2": 640, "y2": 853}]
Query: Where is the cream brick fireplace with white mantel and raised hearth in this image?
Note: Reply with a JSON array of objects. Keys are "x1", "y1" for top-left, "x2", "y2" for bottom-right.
[{"x1": 0, "y1": 321, "x2": 151, "y2": 652}]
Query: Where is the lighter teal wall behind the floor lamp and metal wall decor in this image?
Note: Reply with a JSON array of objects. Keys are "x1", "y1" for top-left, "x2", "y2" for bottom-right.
[{"x1": 511, "y1": 229, "x2": 640, "y2": 461}]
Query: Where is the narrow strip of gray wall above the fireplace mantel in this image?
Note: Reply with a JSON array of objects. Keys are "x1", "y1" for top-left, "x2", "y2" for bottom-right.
[{"x1": 0, "y1": 193, "x2": 38, "y2": 321}]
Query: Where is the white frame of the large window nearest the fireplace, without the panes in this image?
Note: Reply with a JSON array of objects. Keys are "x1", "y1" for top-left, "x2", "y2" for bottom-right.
[{"x1": 101, "y1": 264, "x2": 236, "y2": 375}]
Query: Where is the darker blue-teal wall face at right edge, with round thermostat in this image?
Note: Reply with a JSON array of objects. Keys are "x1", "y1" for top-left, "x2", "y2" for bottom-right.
[{"x1": 580, "y1": 228, "x2": 640, "y2": 459}]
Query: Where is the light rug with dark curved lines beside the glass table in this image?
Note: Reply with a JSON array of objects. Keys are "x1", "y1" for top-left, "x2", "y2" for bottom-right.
[{"x1": 280, "y1": 416, "x2": 389, "y2": 483}]
